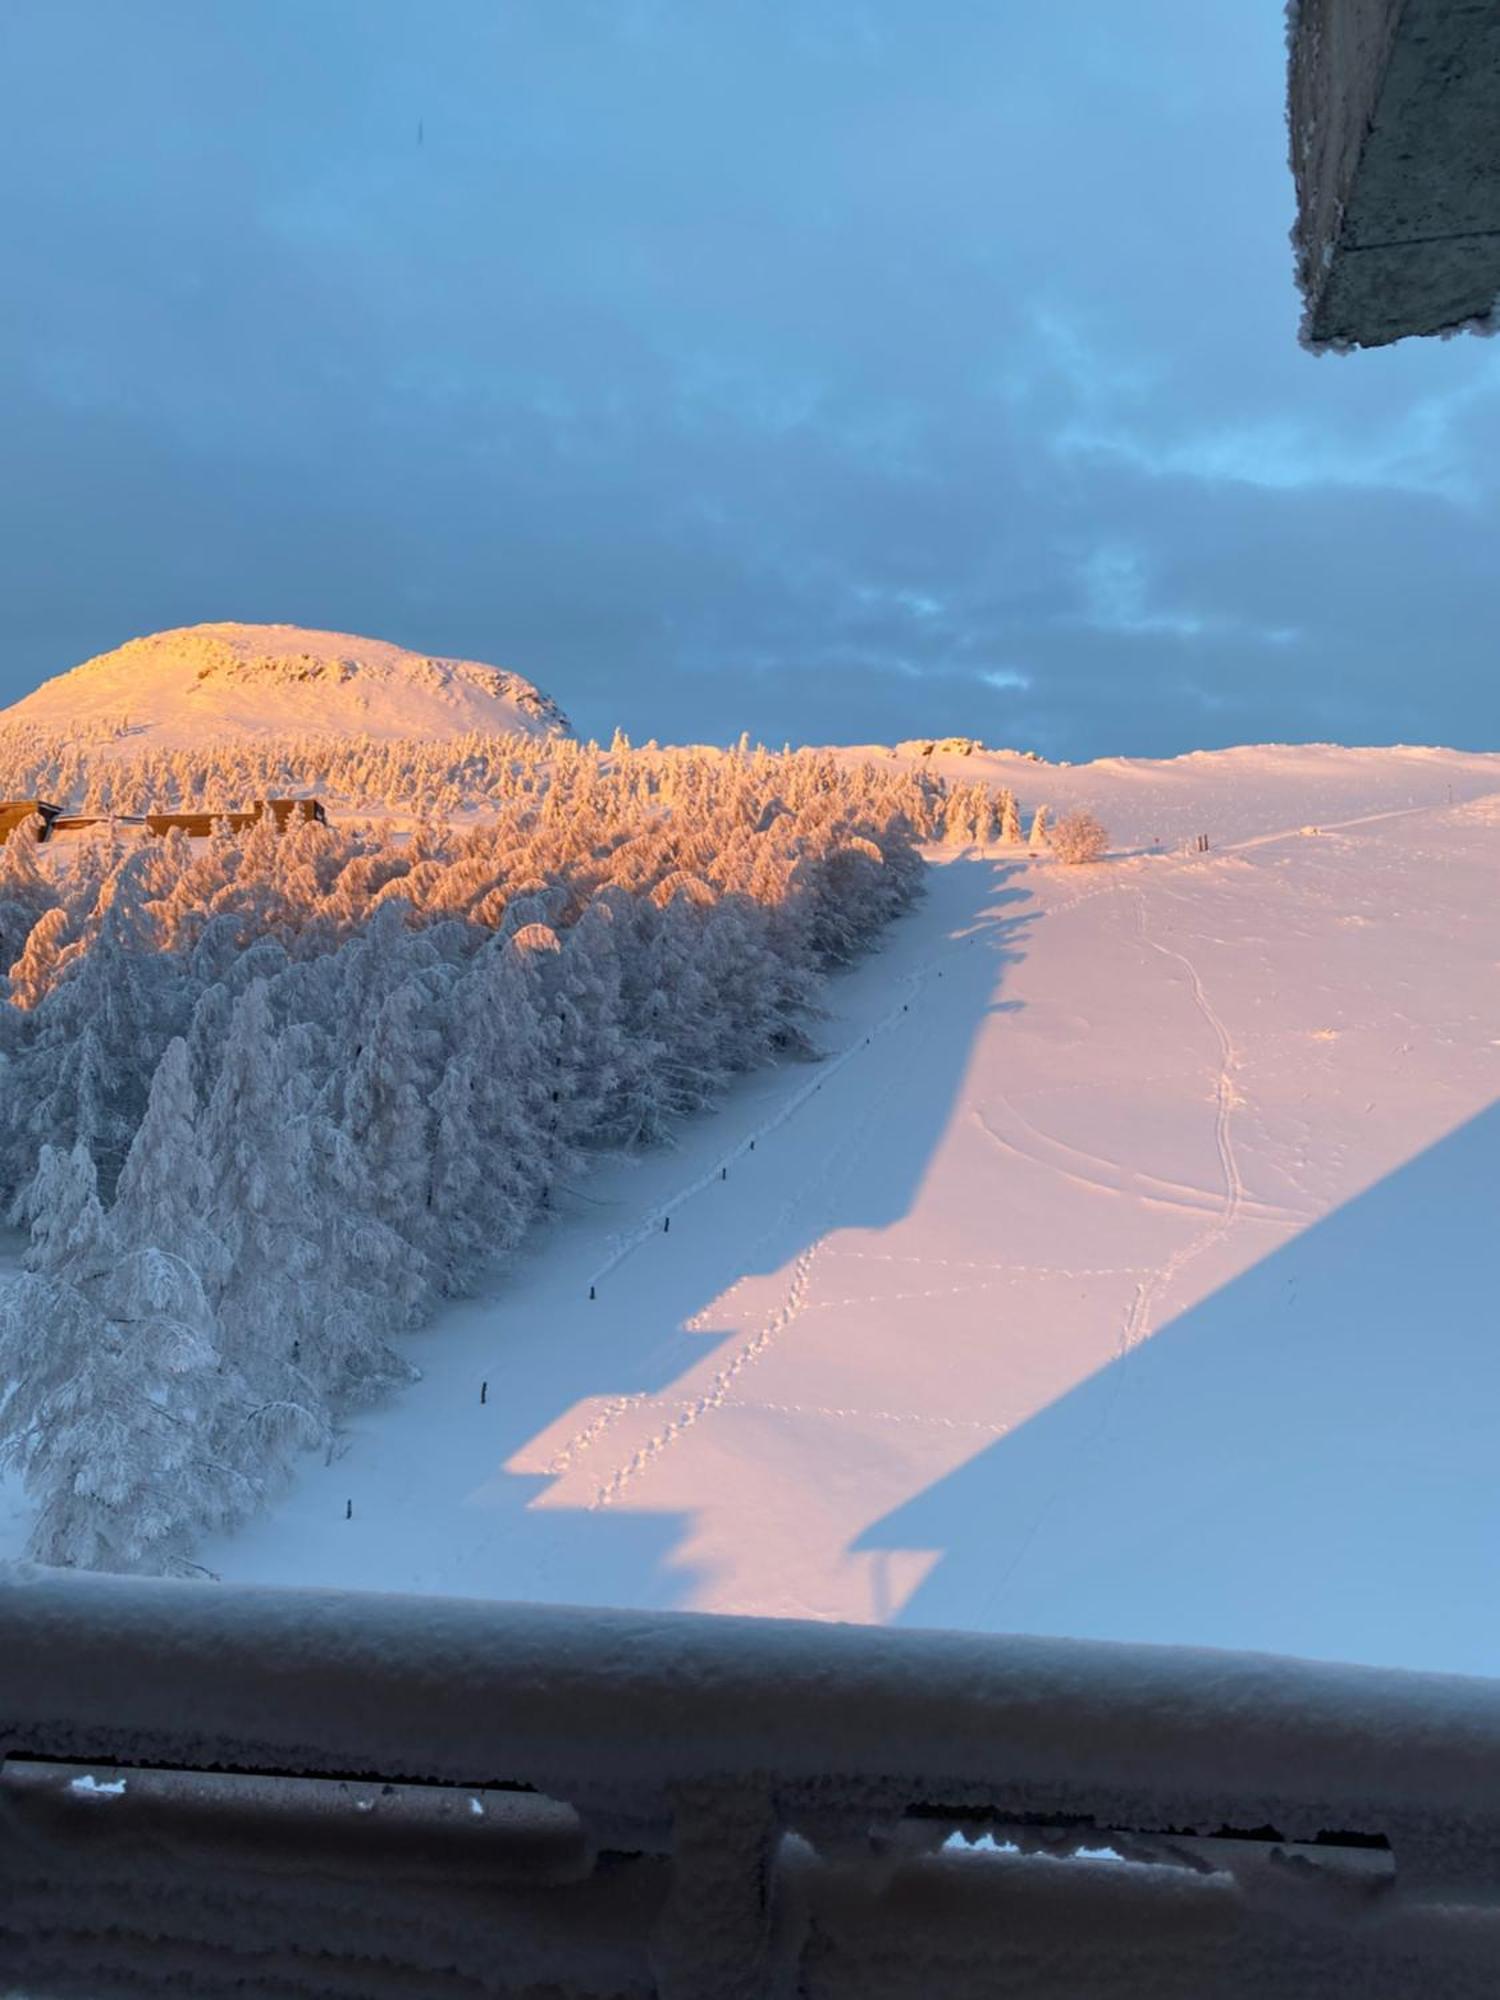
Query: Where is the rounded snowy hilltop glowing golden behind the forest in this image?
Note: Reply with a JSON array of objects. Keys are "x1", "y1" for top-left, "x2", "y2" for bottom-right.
[{"x1": 0, "y1": 624, "x2": 568, "y2": 756}]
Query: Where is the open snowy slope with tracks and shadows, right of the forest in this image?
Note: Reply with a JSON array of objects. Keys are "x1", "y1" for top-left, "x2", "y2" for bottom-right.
[{"x1": 202, "y1": 750, "x2": 1500, "y2": 1674}]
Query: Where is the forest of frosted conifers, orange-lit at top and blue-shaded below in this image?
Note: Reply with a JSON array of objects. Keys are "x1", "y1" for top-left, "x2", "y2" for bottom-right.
[{"x1": 0, "y1": 738, "x2": 1048, "y2": 1570}]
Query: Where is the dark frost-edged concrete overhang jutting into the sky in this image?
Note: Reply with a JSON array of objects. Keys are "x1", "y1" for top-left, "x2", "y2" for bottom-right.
[{"x1": 1290, "y1": 0, "x2": 1500, "y2": 348}]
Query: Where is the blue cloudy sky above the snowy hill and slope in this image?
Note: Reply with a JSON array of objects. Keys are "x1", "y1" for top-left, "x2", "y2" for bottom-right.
[{"x1": 0, "y1": 0, "x2": 1500, "y2": 758}]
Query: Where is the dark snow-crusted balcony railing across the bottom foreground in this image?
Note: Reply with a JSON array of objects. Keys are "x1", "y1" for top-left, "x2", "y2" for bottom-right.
[{"x1": 0, "y1": 1568, "x2": 1500, "y2": 2000}]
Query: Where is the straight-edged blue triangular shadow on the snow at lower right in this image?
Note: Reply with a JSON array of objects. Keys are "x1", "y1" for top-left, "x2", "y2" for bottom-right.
[{"x1": 856, "y1": 1104, "x2": 1500, "y2": 1674}]
